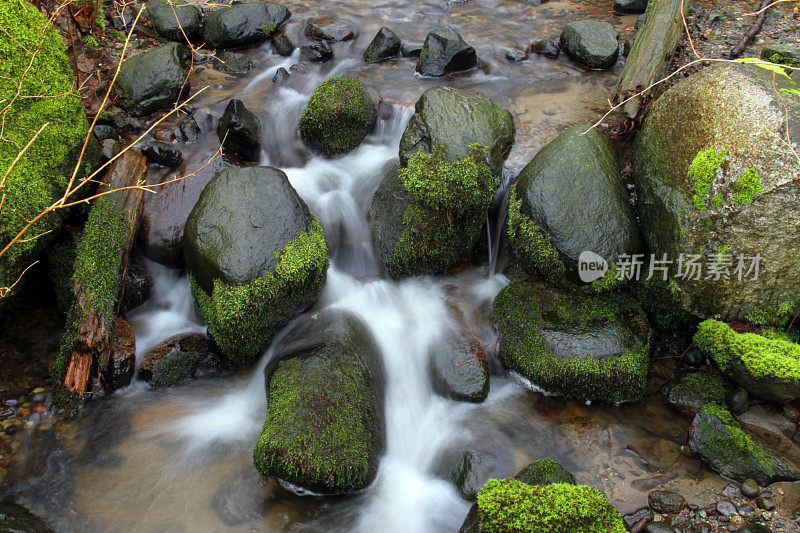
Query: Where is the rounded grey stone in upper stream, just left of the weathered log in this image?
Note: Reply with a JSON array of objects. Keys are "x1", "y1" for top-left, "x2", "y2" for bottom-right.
[{"x1": 561, "y1": 20, "x2": 619, "y2": 70}]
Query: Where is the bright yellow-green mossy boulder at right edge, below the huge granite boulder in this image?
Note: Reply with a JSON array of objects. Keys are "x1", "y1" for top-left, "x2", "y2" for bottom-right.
[{"x1": 694, "y1": 319, "x2": 800, "y2": 404}]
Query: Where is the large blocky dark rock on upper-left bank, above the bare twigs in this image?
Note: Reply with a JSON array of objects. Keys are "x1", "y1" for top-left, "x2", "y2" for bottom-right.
[{"x1": 114, "y1": 43, "x2": 190, "y2": 117}]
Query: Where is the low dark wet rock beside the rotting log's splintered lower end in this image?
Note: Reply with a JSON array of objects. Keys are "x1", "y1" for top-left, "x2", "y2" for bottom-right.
[{"x1": 139, "y1": 333, "x2": 227, "y2": 387}]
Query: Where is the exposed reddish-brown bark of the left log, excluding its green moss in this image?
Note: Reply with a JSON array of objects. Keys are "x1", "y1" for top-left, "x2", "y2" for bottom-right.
[{"x1": 64, "y1": 150, "x2": 147, "y2": 394}]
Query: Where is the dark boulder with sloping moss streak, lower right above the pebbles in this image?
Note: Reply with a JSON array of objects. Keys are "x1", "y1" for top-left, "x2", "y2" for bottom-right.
[{"x1": 689, "y1": 403, "x2": 800, "y2": 487}]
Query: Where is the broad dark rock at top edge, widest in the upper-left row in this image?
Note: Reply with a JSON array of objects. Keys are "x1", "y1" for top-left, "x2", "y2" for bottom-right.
[{"x1": 203, "y1": 2, "x2": 291, "y2": 49}]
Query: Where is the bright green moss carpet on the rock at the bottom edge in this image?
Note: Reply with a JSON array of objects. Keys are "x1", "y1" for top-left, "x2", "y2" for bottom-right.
[{"x1": 478, "y1": 478, "x2": 626, "y2": 533}]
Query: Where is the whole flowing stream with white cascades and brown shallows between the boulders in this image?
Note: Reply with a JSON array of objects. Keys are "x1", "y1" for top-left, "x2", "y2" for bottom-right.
[{"x1": 1, "y1": 0, "x2": 736, "y2": 532}]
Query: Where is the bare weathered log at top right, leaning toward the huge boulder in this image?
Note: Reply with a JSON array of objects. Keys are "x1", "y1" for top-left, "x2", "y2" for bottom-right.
[{"x1": 614, "y1": 0, "x2": 692, "y2": 119}]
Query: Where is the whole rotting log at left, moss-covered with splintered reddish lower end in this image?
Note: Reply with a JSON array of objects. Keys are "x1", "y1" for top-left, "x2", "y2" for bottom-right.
[{"x1": 64, "y1": 150, "x2": 147, "y2": 394}]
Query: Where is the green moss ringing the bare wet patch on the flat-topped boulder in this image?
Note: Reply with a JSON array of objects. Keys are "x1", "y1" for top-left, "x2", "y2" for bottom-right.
[{"x1": 493, "y1": 280, "x2": 650, "y2": 403}]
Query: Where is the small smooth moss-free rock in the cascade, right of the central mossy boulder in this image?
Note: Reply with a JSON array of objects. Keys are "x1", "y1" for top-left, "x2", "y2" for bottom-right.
[{"x1": 428, "y1": 332, "x2": 489, "y2": 403}]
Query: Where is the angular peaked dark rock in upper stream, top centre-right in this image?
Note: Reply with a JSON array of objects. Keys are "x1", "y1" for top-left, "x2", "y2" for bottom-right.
[{"x1": 417, "y1": 26, "x2": 478, "y2": 76}]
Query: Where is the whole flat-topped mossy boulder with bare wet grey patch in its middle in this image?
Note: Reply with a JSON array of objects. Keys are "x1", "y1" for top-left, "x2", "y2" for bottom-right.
[{"x1": 493, "y1": 280, "x2": 650, "y2": 403}]
